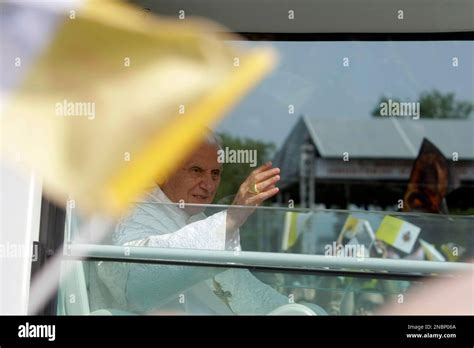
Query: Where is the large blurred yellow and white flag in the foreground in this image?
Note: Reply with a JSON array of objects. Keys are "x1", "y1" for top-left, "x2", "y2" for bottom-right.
[{"x1": 2, "y1": 1, "x2": 275, "y2": 214}]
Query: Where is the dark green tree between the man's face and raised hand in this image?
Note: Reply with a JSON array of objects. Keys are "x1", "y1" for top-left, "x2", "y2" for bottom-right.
[{"x1": 215, "y1": 133, "x2": 275, "y2": 204}]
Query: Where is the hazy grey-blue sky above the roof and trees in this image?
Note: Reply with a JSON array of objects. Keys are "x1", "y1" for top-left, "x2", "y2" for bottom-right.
[{"x1": 216, "y1": 41, "x2": 474, "y2": 147}]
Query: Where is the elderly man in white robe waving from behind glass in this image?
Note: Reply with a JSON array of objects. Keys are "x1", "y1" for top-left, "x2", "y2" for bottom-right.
[{"x1": 93, "y1": 135, "x2": 300, "y2": 314}]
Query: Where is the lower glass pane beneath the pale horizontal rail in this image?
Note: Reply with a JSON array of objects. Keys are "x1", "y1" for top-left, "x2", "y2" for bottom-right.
[{"x1": 58, "y1": 261, "x2": 424, "y2": 315}]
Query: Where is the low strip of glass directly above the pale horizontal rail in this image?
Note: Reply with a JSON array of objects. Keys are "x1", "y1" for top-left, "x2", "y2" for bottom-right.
[{"x1": 66, "y1": 202, "x2": 474, "y2": 262}]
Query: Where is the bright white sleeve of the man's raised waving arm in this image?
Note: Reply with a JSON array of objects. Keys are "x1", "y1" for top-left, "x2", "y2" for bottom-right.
[{"x1": 123, "y1": 211, "x2": 240, "y2": 250}]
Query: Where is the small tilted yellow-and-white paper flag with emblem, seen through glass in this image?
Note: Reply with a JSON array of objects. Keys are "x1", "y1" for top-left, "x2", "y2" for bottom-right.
[{"x1": 375, "y1": 216, "x2": 421, "y2": 254}]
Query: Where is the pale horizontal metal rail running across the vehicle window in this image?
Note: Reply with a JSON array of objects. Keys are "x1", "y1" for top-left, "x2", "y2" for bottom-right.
[{"x1": 64, "y1": 244, "x2": 474, "y2": 278}]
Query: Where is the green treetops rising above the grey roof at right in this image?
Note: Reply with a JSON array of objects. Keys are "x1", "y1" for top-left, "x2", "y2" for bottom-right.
[{"x1": 372, "y1": 89, "x2": 474, "y2": 119}]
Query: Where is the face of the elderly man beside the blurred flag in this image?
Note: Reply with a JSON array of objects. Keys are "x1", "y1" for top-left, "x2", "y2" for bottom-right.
[{"x1": 161, "y1": 144, "x2": 222, "y2": 214}]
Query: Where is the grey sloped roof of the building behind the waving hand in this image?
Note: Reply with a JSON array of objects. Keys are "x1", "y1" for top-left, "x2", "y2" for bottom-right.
[{"x1": 274, "y1": 116, "x2": 474, "y2": 184}]
